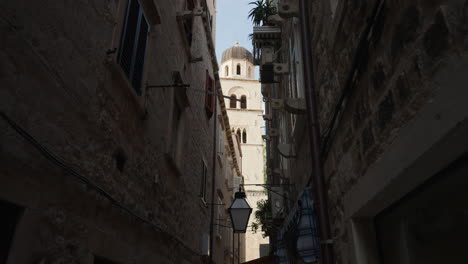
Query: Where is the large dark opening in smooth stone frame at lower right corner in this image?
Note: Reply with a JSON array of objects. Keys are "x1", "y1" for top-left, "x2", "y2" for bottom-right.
[{"x1": 375, "y1": 154, "x2": 468, "y2": 264}]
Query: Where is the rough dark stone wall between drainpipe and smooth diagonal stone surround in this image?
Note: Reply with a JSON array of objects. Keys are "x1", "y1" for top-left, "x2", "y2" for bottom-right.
[{"x1": 304, "y1": 1, "x2": 468, "y2": 263}]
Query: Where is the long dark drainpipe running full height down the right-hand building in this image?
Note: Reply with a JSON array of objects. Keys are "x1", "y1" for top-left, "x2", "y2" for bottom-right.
[{"x1": 299, "y1": 0, "x2": 334, "y2": 264}]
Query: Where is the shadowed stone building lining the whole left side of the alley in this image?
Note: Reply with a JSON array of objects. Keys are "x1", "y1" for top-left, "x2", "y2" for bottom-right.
[{"x1": 0, "y1": 0, "x2": 245, "y2": 264}]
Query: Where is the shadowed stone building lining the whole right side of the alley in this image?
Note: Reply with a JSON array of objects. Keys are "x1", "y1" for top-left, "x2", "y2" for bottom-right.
[{"x1": 254, "y1": 0, "x2": 468, "y2": 264}]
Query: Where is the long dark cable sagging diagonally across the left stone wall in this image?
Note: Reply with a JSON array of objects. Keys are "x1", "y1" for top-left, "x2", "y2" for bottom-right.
[{"x1": 0, "y1": 112, "x2": 202, "y2": 256}]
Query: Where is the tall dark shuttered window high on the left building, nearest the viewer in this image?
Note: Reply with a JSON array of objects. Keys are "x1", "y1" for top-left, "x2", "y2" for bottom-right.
[{"x1": 117, "y1": 0, "x2": 149, "y2": 95}]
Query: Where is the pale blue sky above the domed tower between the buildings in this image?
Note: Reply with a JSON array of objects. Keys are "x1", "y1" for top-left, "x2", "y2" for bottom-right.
[{"x1": 216, "y1": 0, "x2": 254, "y2": 63}]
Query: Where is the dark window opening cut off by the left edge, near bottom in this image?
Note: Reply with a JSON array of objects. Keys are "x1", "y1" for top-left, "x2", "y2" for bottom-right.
[{"x1": 0, "y1": 200, "x2": 23, "y2": 263}]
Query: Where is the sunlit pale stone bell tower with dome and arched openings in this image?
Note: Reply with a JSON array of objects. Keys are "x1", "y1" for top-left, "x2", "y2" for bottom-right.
[{"x1": 220, "y1": 43, "x2": 268, "y2": 261}]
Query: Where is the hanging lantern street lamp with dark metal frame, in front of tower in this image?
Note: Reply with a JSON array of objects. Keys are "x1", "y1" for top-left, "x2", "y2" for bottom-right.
[{"x1": 228, "y1": 186, "x2": 252, "y2": 233}]
